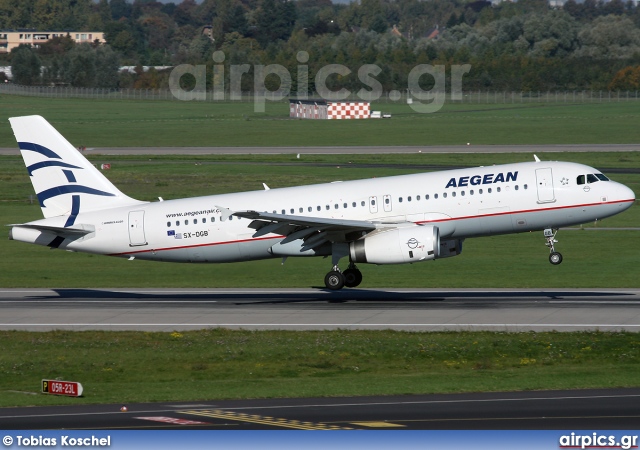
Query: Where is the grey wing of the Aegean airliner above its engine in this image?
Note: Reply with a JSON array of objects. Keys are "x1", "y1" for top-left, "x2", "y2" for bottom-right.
[{"x1": 233, "y1": 211, "x2": 384, "y2": 250}]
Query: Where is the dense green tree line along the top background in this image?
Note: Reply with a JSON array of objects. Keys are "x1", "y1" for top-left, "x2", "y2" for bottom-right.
[{"x1": 0, "y1": 0, "x2": 640, "y2": 92}]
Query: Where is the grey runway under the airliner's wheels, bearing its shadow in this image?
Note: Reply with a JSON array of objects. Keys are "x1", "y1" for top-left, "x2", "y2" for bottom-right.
[{"x1": 0, "y1": 289, "x2": 640, "y2": 332}]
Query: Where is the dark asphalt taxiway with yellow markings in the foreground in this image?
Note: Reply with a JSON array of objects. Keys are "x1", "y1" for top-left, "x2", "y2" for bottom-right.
[{"x1": 0, "y1": 389, "x2": 640, "y2": 430}]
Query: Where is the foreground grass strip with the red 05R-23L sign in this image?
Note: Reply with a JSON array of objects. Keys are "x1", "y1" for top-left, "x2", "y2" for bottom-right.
[{"x1": 0, "y1": 329, "x2": 640, "y2": 406}]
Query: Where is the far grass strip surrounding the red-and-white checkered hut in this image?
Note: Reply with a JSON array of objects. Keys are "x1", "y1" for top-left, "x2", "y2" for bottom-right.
[{"x1": 0, "y1": 95, "x2": 640, "y2": 148}]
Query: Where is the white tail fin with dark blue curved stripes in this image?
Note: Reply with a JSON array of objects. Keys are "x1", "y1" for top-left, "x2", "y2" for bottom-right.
[{"x1": 9, "y1": 116, "x2": 143, "y2": 221}]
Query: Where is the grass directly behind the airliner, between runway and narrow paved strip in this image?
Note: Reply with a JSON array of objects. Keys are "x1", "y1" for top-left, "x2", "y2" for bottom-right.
[{"x1": 0, "y1": 153, "x2": 640, "y2": 288}]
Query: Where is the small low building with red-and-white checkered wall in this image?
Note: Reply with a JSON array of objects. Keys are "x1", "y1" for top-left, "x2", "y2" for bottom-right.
[{"x1": 289, "y1": 99, "x2": 371, "y2": 119}]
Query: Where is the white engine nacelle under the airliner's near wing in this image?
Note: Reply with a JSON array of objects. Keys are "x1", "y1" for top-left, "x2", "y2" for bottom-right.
[{"x1": 349, "y1": 225, "x2": 440, "y2": 264}]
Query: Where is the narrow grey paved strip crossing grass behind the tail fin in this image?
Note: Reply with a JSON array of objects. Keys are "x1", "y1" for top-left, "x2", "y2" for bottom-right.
[{"x1": 0, "y1": 144, "x2": 640, "y2": 155}]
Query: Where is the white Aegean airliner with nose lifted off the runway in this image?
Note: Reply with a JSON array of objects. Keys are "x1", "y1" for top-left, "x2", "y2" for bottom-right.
[{"x1": 9, "y1": 116, "x2": 635, "y2": 290}]
